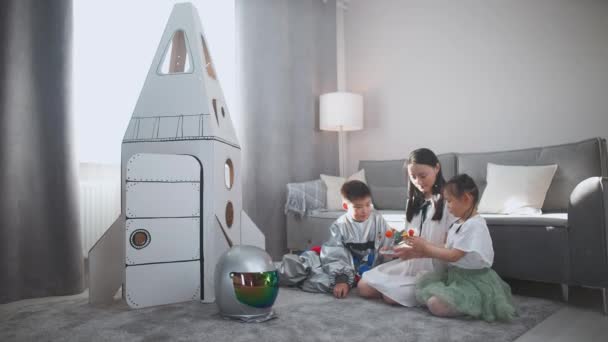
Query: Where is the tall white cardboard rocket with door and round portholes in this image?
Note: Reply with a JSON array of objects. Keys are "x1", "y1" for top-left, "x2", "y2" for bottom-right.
[{"x1": 87, "y1": 3, "x2": 264, "y2": 308}]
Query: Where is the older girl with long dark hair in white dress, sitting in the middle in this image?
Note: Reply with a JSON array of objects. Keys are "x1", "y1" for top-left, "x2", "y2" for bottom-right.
[{"x1": 357, "y1": 148, "x2": 456, "y2": 306}]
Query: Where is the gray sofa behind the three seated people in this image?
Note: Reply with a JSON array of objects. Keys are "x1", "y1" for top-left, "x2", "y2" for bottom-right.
[{"x1": 287, "y1": 138, "x2": 608, "y2": 311}]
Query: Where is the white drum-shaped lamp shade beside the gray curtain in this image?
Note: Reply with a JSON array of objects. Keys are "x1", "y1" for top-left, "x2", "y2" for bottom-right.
[{"x1": 319, "y1": 92, "x2": 363, "y2": 131}]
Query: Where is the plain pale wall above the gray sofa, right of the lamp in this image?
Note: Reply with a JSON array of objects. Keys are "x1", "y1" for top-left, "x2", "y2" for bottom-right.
[{"x1": 345, "y1": 0, "x2": 608, "y2": 173}]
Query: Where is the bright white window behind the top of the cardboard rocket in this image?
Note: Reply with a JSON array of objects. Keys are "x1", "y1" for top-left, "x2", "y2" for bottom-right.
[{"x1": 72, "y1": 0, "x2": 236, "y2": 164}]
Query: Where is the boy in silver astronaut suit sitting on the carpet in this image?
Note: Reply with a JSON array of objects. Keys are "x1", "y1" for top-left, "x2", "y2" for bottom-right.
[{"x1": 277, "y1": 180, "x2": 392, "y2": 298}]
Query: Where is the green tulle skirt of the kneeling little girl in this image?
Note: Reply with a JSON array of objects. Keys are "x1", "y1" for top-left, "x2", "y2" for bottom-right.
[{"x1": 416, "y1": 267, "x2": 515, "y2": 322}]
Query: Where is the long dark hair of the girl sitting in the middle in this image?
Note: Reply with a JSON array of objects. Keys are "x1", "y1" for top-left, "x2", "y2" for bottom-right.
[{"x1": 405, "y1": 148, "x2": 445, "y2": 222}]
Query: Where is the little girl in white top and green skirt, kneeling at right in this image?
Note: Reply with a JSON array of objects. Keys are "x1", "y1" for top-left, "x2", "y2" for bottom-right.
[{"x1": 406, "y1": 174, "x2": 515, "y2": 322}]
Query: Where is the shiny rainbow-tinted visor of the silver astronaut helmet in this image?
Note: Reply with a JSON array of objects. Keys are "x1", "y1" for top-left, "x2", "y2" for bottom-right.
[{"x1": 230, "y1": 271, "x2": 279, "y2": 308}]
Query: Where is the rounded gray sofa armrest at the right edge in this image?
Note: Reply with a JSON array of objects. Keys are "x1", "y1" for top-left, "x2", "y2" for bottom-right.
[{"x1": 568, "y1": 177, "x2": 608, "y2": 287}]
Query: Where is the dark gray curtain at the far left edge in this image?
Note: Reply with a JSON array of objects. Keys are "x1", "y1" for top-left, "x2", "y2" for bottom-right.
[{"x1": 0, "y1": 0, "x2": 83, "y2": 303}]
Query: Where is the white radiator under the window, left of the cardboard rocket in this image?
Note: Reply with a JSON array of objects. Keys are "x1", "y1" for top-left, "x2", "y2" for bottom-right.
[{"x1": 79, "y1": 164, "x2": 120, "y2": 256}]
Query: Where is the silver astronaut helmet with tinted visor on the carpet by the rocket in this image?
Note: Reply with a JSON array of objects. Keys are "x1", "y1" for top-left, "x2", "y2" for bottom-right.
[{"x1": 215, "y1": 246, "x2": 279, "y2": 322}]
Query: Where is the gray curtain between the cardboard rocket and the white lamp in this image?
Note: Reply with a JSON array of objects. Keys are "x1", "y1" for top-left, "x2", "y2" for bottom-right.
[{"x1": 233, "y1": 0, "x2": 338, "y2": 260}]
